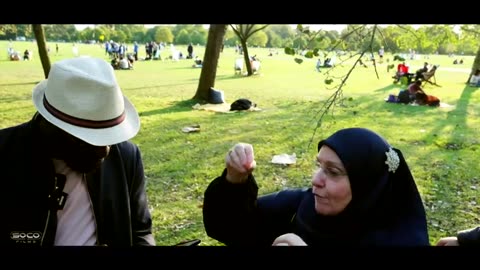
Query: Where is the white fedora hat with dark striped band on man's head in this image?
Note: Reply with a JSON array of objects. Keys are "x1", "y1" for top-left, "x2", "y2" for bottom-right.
[{"x1": 32, "y1": 57, "x2": 140, "y2": 146}]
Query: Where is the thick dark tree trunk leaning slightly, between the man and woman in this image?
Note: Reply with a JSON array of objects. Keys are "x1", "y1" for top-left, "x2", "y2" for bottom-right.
[{"x1": 193, "y1": 24, "x2": 227, "y2": 101}]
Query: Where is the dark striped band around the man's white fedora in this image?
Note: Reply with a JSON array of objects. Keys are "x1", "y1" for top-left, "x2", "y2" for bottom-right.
[{"x1": 43, "y1": 95, "x2": 125, "y2": 128}]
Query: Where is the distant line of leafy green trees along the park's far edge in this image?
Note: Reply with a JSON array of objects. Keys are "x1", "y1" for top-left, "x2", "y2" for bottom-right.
[{"x1": 0, "y1": 24, "x2": 480, "y2": 55}]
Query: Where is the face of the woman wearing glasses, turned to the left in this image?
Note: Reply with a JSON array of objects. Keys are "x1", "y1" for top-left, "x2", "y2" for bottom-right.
[{"x1": 312, "y1": 145, "x2": 352, "y2": 216}]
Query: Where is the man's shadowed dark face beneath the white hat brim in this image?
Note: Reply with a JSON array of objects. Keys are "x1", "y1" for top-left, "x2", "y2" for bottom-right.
[{"x1": 40, "y1": 116, "x2": 110, "y2": 173}]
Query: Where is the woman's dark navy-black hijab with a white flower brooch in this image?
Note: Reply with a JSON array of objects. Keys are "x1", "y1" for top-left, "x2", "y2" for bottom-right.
[{"x1": 298, "y1": 128, "x2": 426, "y2": 246}]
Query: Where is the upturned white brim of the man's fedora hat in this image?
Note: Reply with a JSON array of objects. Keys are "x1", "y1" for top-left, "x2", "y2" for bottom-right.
[{"x1": 32, "y1": 79, "x2": 140, "y2": 146}]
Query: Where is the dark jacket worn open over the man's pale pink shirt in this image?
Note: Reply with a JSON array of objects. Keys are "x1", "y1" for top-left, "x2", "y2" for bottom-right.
[{"x1": 0, "y1": 121, "x2": 155, "y2": 247}]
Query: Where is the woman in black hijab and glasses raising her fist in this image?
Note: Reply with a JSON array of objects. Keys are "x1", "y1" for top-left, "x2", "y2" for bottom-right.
[{"x1": 203, "y1": 128, "x2": 429, "y2": 246}]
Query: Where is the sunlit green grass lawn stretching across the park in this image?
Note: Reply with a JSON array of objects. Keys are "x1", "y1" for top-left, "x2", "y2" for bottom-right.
[{"x1": 0, "y1": 42, "x2": 480, "y2": 245}]
